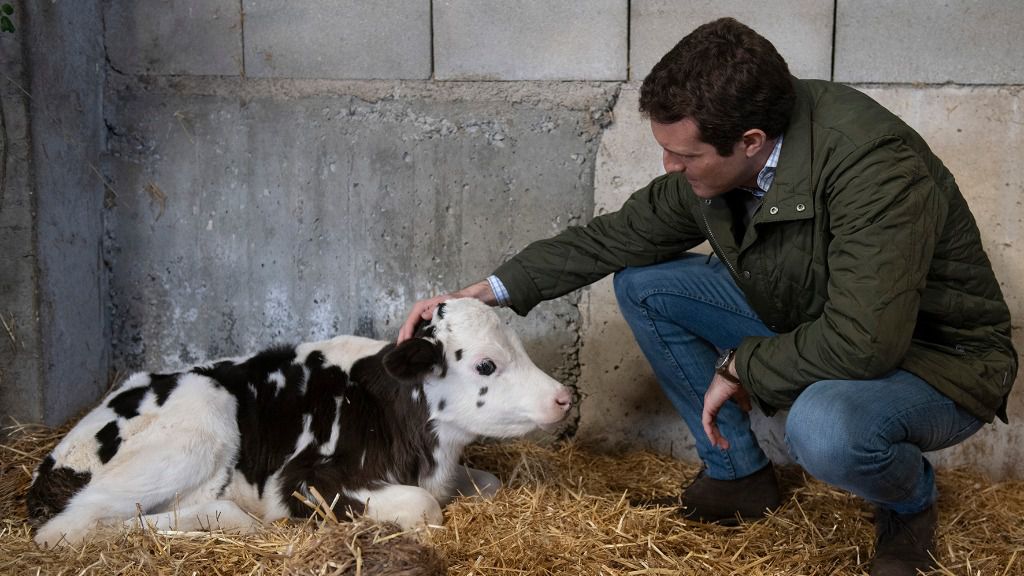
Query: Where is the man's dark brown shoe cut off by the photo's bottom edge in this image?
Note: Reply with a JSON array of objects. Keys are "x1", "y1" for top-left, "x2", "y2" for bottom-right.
[{"x1": 871, "y1": 504, "x2": 939, "y2": 576}]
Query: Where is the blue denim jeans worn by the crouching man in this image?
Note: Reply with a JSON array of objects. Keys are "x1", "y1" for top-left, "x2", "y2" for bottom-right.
[{"x1": 614, "y1": 254, "x2": 982, "y2": 513}]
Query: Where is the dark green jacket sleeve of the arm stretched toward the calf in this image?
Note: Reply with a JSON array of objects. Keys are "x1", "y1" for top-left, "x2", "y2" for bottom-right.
[{"x1": 494, "y1": 174, "x2": 705, "y2": 316}]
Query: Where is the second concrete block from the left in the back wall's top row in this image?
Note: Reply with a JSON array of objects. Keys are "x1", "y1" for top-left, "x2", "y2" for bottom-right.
[{"x1": 243, "y1": 0, "x2": 431, "y2": 79}]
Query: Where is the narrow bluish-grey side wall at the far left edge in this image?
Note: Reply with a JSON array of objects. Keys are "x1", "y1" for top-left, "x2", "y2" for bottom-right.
[{"x1": 0, "y1": 2, "x2": 110, "y2": 424}]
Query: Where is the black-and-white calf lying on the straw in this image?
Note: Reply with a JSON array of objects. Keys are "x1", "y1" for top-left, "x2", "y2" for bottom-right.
[{"x1": 28, "y1": 299, "x2": 571, "y2": 546}]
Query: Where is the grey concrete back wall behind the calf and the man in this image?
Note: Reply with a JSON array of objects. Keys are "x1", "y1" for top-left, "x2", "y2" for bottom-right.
[{"x1": 0, "y1": 0, "x2": 1024, "y2": 477}]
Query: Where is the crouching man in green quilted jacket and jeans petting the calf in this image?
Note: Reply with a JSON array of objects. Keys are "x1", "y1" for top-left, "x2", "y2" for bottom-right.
[{"x1": 399, "y1": 18, "x2": 1017, "y2": 575}]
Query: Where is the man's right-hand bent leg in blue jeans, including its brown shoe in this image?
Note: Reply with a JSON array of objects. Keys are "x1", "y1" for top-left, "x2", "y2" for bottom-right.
[{"x1": 785, "y1": 370, "x2": 982, "y2": 576}]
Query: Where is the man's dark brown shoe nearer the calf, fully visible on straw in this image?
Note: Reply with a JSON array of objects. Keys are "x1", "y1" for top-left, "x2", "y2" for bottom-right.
[{"x1": 640, "y1": 464, "x2": 780, "y2": 526}]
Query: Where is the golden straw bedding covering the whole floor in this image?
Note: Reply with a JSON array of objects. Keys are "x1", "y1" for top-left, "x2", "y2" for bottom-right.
[{"x1": 0, "y1": 420, "x2": 1024, "y2": 576}]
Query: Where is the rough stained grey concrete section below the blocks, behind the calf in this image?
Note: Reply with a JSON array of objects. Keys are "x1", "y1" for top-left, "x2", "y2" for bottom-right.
[{"x1": 101, "y1": 83, "x2": 615, "y2": 416}]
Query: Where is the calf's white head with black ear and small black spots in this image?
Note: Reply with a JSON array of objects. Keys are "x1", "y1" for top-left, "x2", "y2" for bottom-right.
[{"x1": 384, "y1": 298, "x2": 572, "y2": 438}]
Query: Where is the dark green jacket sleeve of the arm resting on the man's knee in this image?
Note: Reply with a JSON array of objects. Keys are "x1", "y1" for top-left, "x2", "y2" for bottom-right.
[{"x1": 736, "y1": 137, "x2": 946, "y2": 410}]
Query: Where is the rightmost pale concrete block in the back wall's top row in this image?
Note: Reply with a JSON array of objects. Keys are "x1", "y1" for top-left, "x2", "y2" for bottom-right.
[{"x1": 836, "y1": 0, "x2": 1024, "y2": 84}]
